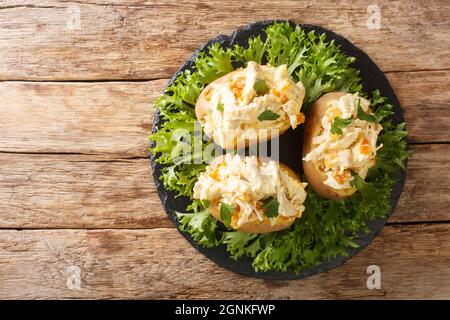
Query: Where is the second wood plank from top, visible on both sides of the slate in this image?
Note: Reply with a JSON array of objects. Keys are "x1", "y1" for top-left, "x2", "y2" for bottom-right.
[{"x1": 0, "y1": 71, "x2": 450, "y2": 157}]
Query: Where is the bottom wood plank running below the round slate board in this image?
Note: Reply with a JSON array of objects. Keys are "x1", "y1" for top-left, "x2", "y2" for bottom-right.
[{"x1": 0, "y1": 224, "x2": 450, "y2": 299}]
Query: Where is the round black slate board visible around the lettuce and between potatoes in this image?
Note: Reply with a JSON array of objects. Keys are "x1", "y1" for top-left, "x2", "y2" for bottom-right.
[{"x1": 150, "y1": 20, "x2": 405, "y2": 280}]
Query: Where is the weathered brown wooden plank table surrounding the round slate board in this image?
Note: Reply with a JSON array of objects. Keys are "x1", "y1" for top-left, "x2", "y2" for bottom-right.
[{"x1": 0, "y1": 0, "x2": 450, "y2": 299}]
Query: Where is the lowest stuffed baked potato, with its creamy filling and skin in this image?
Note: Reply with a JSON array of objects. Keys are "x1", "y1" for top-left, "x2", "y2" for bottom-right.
[{"x1": 194, "y1": 154, "x2": 306, "y2": 233}]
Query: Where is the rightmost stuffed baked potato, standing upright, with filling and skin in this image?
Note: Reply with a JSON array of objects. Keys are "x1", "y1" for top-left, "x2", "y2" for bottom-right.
[{"x1": 302, "y1": 92, "x2": 382, "y2": 199}]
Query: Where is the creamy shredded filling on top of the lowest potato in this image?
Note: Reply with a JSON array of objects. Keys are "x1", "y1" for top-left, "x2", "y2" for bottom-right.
[{"x1": 194, "y1": 154, "x2": 307, "y2": 229}]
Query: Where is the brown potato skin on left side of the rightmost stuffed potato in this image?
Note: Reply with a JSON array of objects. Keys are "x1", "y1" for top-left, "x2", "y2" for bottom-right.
[{"x1": 302, "y1": 92, "x2": 356, "y2": 199}]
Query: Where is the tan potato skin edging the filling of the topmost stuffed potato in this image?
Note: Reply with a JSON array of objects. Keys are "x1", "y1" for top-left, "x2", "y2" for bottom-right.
[{"x1": 195, "y1": 66, "x2": 292, "y2": 150}]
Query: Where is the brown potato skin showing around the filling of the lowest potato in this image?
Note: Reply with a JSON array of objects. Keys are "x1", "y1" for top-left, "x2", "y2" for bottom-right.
[{"x1": 209, "y1": 156, "x2": 300, "y2": 233}]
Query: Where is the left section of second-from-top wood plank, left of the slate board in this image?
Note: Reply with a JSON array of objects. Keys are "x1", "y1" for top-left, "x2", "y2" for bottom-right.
[{"x1": 0, "y1": 80, "x2": 166, "y2": 157}]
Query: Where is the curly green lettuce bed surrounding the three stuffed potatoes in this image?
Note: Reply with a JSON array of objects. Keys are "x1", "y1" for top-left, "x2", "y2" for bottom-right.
[{"x1": 150, "y1": 23, "x2": 411, "y2": 272}]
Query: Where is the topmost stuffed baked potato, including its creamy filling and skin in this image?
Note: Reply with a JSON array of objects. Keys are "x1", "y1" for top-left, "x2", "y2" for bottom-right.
[{"x1": 195, "y1": 61, "x2": 305, "y2": 149}]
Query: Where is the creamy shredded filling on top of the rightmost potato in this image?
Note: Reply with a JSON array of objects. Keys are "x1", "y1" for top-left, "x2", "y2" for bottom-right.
[{"x1": 303, "y1": 94, "x2": 383, "y2": 191}]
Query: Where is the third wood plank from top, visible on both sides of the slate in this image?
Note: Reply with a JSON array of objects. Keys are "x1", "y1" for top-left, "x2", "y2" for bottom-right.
[{"x1": 0, "y1": 145, "x2": 450, "y2": 228}]
